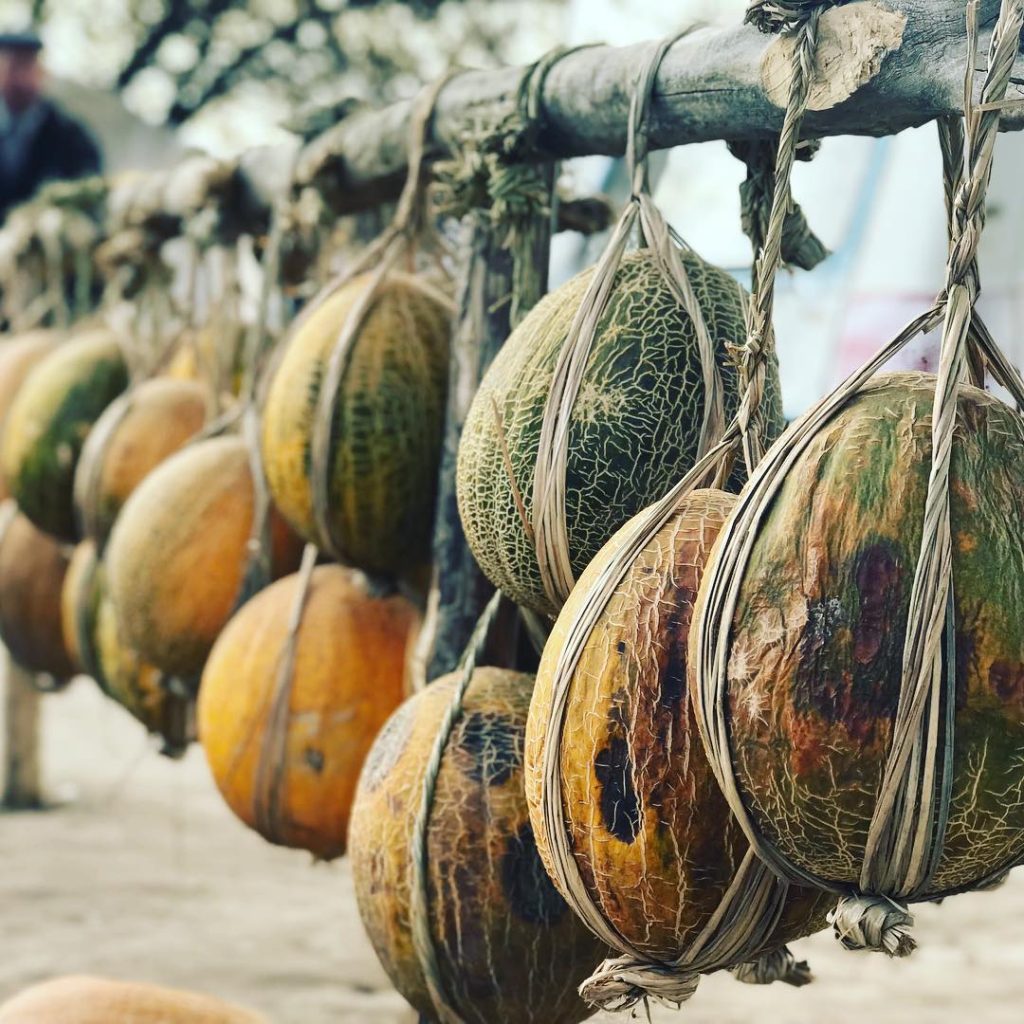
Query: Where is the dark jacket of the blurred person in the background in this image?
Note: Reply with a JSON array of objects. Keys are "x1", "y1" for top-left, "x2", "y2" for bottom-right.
[{"x1": 0, "y1": 100, "x2": 102, "y2": 221}]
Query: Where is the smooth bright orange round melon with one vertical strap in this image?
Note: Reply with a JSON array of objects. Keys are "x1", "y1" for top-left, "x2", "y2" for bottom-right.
[{"x1": 199, "y1": 565, "x2": 419, "y2": 860}]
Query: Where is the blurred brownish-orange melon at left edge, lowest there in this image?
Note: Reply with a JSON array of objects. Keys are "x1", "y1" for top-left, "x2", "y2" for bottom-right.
[{"x1": 0, "y1": 499, "x2": 75, "y2": 680}]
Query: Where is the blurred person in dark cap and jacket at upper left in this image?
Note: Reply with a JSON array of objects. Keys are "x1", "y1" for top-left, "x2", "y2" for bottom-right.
[{"x1": 0, "y1": 32, "x2": 102, "y2": 221}]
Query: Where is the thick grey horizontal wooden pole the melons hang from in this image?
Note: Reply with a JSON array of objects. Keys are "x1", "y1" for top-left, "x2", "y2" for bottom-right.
[{"x1": 298, "y1": 0, "x2": 1024, "y2": 212}]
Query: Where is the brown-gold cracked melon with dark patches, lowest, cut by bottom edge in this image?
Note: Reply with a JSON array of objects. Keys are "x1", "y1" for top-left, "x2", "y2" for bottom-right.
[{"x1": 349, "y1": 669, "x2": 607, "y2": 1024}]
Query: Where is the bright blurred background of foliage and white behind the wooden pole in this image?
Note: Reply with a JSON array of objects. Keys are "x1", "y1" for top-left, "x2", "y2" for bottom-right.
[{"x1": 8, "y1": 0, "x2": 1024, "y2": 416}]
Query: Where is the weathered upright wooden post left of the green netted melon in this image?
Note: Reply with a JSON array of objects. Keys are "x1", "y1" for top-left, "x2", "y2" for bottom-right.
[{"x1": 426, "y1": 181, "x2": 551, "y2": 680}]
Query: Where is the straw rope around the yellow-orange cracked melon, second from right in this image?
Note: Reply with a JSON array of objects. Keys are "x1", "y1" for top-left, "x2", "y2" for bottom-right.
[{"x1": 541, "y1": 11, "x2": 835, "y2": 1010}]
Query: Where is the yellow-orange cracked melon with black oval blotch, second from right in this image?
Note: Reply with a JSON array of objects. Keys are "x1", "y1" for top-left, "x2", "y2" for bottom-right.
[{"x1": 526, "y1": 489, "x2": 835, "y2": 959}]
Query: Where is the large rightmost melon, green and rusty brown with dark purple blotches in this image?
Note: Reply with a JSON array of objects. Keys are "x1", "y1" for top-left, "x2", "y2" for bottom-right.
[{"x1": 709, "y1": 374, "x2": 1024, "y2": 898}]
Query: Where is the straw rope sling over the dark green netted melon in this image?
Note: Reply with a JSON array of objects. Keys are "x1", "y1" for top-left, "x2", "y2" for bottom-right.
[{"x1": 532, "y1": 29, "x2": 725, "y2": 607}]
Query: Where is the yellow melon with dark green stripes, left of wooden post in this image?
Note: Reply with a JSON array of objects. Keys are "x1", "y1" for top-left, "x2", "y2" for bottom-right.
[{"x1": 262, "y1": 273, "x2": 451, "y2": 572}]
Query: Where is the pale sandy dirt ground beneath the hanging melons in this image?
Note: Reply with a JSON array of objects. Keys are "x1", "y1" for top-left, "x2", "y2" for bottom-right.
[{"x1": 0, "y1": 680, "x2": 1024, "y2": 1024}]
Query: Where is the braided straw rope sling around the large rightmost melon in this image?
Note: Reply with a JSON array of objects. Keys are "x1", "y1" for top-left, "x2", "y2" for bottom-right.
[{"x1": 693, "y1": 0, "x2": 1024, "y2": 956}]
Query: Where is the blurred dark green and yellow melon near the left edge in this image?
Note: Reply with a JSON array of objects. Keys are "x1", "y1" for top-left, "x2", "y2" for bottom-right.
[{"x1": 0, "y1": 328, "x2": 128, "y2": 541}]
